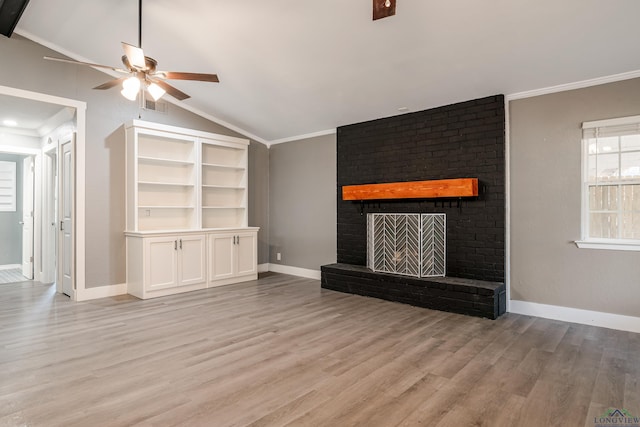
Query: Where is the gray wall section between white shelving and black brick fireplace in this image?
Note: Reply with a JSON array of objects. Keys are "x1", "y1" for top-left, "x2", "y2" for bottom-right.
[{"x1": 269, "y1": 134, "x2": 336, "y2": 270}]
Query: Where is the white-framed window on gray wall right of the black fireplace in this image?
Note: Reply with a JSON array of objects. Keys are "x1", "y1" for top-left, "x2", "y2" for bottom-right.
[{"x1": 576, "y1": 116, "x2": 640, "y2": 250}]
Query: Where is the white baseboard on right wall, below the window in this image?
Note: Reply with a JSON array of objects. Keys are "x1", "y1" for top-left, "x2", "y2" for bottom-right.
[{"x1": 509, "y1": 300, "x2": 640, "y2": 333}]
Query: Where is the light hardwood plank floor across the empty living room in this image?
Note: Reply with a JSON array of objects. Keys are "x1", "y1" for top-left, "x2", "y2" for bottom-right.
[{"x1": 0, "y1": 273, "x2": 640, "y2": 427}]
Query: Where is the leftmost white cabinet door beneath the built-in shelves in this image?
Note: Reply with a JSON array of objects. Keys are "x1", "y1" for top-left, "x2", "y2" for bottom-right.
[{"x1": 143, "y1": 236, "x2": 178, "y2": 291}]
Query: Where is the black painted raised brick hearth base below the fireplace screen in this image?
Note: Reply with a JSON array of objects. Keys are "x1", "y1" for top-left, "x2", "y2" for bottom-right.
[{"x1": 321, "y1": 264, "x2": 506, "y2": 319}]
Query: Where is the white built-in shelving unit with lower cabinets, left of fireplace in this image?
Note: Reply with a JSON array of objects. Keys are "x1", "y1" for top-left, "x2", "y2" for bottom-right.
[{"x1": 125, "y1": 120, "x2": 258, "y2": 298}]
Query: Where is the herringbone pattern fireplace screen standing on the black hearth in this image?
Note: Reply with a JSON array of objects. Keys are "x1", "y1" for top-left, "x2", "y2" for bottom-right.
[{"x1": 367, "y1": 214, "x2": 446, "y2": 277}]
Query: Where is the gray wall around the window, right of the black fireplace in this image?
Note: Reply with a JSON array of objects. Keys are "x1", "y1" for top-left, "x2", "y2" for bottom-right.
[{"x1": 509, "y1": 79, "x2": 640, "y2": 317}]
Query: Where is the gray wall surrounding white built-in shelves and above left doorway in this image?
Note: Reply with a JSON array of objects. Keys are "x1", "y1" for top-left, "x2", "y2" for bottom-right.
[{"x1": 0, "y1": 34, "x2": 268, "y2": 287}]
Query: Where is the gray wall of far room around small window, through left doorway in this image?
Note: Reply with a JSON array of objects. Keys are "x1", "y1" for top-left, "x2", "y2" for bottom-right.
[{"x1": 0, "y1": 153, "x2": 24, "y2": 265}]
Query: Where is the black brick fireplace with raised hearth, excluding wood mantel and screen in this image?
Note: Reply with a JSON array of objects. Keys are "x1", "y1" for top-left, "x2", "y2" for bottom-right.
[{"x1": 322, "y1": 95, "x2": 505, "y2": 318}]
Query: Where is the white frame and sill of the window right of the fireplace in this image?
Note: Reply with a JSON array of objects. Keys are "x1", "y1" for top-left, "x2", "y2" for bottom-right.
[{"x1": 575, "y1": 116, "x2": 640, "y2": 251}]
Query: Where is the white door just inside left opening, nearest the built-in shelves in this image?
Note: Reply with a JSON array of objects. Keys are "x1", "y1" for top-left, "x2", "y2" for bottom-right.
[{"x1": 58, "y1": 134, "x2": 75, "y2": 296}]
